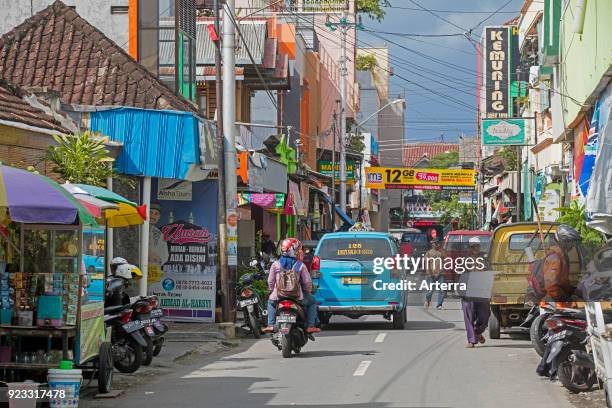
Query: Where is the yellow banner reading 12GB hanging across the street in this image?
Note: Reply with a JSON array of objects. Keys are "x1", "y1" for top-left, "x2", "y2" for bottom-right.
[{"x1": 365, "y1": 167, "x2": 476, "y2": 190}]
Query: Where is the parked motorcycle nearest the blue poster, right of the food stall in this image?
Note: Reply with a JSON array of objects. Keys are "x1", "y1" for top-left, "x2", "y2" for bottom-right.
[{"x1": 132, "y1": 296, "x2": 168, "y2": 366}]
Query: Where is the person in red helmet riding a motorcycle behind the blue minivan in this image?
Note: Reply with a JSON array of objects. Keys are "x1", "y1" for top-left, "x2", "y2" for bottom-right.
[{"x1": 263, "y1": 238, "x2": 321, "y2": 333}]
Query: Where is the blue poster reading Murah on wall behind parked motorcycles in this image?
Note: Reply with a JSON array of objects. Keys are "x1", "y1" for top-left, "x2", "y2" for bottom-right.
[{"x1": 148, "y1": 180, "x2": 217, "y2": 322}]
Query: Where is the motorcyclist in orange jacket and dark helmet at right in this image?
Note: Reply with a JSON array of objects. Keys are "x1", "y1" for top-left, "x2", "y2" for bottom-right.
[{"x1": 543, "y1": 224, "x2": 581, "y2": 302}]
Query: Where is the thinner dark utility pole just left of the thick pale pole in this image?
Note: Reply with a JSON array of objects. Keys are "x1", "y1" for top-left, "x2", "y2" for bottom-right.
[{"x1": 214, "y1": 0, "x2": 231, "y2": 321}]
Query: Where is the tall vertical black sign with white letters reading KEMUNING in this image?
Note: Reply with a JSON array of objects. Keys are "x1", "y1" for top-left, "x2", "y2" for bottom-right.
[{"x1": 484, "y1": 27, "x2": 512, "y2": 119}]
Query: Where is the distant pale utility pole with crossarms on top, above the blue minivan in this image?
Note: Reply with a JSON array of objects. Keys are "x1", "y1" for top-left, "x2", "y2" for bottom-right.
[{"x1": 325, "y1": 10, "x2": 363, "y2": 211}]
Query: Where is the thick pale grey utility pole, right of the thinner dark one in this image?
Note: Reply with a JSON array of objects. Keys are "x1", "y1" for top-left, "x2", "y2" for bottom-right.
[{"x1": 221, "y1": 0, "x2": 238, "y2": 322}]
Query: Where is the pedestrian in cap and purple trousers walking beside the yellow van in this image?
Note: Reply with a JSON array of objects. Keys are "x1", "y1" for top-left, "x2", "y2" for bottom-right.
[{"x1": 459, "y1": 237, "x2": 491, "y2": 348}]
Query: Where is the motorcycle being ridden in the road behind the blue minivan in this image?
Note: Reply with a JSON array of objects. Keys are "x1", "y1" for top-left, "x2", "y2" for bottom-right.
[{"x1": 271, "y1": 299, "x2": 315, "y2": 358}]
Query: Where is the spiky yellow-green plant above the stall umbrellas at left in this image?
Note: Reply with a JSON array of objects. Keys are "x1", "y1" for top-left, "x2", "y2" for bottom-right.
[{"x1": 46, "y1": 131, "x2": 114, "y2": 186}]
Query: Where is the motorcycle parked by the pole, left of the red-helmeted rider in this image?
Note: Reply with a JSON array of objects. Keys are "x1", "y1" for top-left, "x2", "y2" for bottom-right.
[{"x1": 236, "y1": 259, "x2": 268, "y2": 339}]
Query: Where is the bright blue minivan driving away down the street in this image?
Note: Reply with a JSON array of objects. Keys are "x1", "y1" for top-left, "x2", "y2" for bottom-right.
[{"x1": 311, "y1": 232, "x2": 406, "y2": 329}]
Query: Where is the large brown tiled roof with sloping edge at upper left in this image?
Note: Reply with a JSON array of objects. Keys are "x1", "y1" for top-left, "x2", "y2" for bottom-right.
[{"x1": 0, "y1": 0, "x2": 196, "y2": 112}]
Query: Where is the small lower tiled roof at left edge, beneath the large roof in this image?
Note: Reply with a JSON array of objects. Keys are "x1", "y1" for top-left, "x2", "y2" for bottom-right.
[{"x1": 0, "y1": 80, "x2": 70, "y2": 134}]
